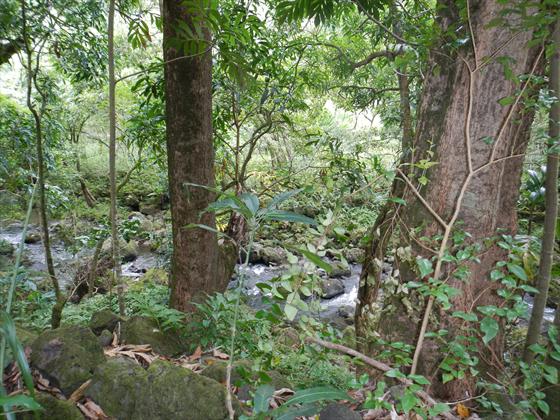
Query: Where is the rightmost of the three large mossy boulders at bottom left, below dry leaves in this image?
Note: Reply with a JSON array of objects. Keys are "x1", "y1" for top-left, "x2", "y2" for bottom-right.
[{"x1": 148, "y1": 360, "x2": 241, "y2": 420}]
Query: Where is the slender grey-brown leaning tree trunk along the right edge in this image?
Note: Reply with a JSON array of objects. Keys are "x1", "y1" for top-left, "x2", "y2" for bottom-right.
[{"x1": 523, "y1": 17, "x2": 560, "y2": 363}]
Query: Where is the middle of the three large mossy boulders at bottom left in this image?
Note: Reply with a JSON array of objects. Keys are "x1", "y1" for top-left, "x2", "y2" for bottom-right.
[{"x1": 85, "y1": 357, "x2": 149, "y2": 420}]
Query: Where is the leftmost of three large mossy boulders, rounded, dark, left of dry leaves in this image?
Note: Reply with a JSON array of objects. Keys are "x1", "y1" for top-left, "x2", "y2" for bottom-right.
[{"x1": 31, "y1": 326, "x2": 105, "y2": 396}]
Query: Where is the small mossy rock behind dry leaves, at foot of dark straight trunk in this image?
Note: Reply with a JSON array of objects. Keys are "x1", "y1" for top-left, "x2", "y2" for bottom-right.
[{"x1": 121, "y1": 316, "x2": 187, "y2": 357}]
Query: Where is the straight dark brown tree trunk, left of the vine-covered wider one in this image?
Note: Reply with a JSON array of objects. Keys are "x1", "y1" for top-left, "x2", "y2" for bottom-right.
[{"x1": 163, "y1": 0, "x2": 225, "y2": 311}]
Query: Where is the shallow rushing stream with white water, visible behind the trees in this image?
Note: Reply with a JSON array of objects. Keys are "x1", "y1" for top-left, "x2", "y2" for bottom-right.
[{"x1": 0, "y1": 223, "x2": 555, "y2": 329}]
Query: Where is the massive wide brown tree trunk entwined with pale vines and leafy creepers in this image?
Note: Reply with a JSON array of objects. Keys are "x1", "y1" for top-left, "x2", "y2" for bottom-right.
[{"x1": 356, "y1": 0, "x2": 541, "y2": 399}]
